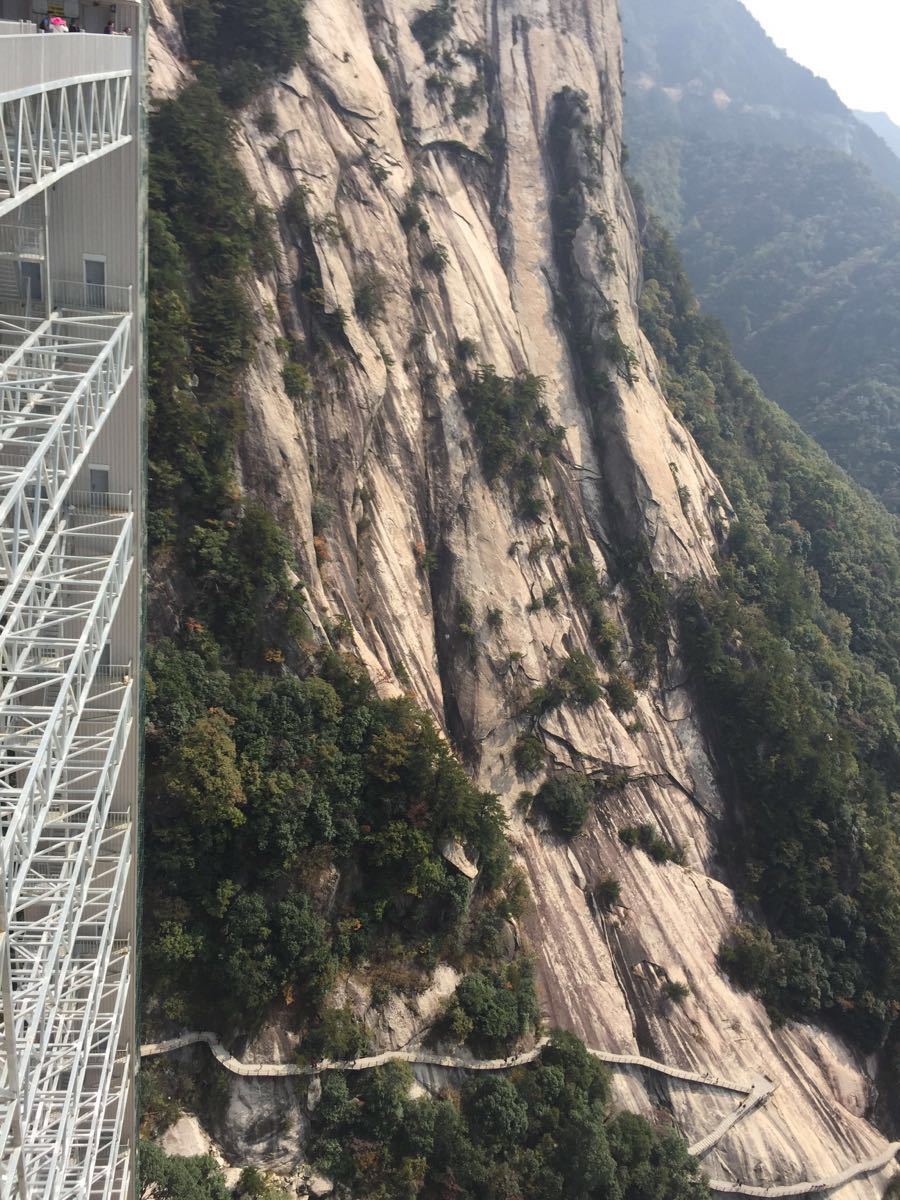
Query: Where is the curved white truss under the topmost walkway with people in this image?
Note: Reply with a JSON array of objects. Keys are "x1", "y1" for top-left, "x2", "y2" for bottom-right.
[{"x1": 0, "y1": 71, "x2": 132, "y2": 216}]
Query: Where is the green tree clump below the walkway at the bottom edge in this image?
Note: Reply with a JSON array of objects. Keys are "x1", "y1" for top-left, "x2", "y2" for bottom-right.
[{"x1": 311, "y1": 1033, "x2": 709, "y2": 1200}]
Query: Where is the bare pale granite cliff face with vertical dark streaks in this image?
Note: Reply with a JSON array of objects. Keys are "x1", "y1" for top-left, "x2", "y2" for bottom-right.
[{"x1": 151, "y1": 0, "x2": 888, "y2": 1198}]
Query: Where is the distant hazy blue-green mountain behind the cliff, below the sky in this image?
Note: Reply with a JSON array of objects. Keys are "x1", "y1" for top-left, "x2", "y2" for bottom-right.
[{"x1": 623, "y1": 0, "x2": 900, "y2": 510}]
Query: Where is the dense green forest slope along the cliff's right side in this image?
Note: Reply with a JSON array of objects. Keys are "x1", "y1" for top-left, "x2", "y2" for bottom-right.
[{"x1": 638, "y1": 189, "x2": 900, "y2": 1048}]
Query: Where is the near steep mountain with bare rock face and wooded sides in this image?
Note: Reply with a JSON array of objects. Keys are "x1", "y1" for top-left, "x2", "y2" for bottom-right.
[{"x1": 142, "y1": 0, "x2": 900, "y2": 1200}]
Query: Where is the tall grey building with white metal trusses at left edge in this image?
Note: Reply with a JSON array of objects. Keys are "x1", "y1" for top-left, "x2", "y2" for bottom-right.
[{"x1": 0, "y1": 9, "x2": 146, "y2": 1200}]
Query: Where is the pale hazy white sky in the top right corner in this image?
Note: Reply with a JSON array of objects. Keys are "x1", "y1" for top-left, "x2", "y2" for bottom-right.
[{"x1": 743, "y1": 0, "x2": 900, "y2": 125}]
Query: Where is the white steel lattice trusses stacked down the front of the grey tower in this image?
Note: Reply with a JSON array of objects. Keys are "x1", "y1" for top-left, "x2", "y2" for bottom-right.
[{"x1": 0, "y1": 140, "x2": 136, "y2": 1200}]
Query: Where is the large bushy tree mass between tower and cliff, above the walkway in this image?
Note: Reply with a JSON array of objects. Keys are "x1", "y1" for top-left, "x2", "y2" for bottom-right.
[{"x1": 144, "y1": 630, "x2": 518, "y2": 1049}]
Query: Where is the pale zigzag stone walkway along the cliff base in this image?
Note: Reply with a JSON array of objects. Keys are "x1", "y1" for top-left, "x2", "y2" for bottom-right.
[{"x1": 140, "y1": 1032, "x2": 900, "y2": 1196}]
